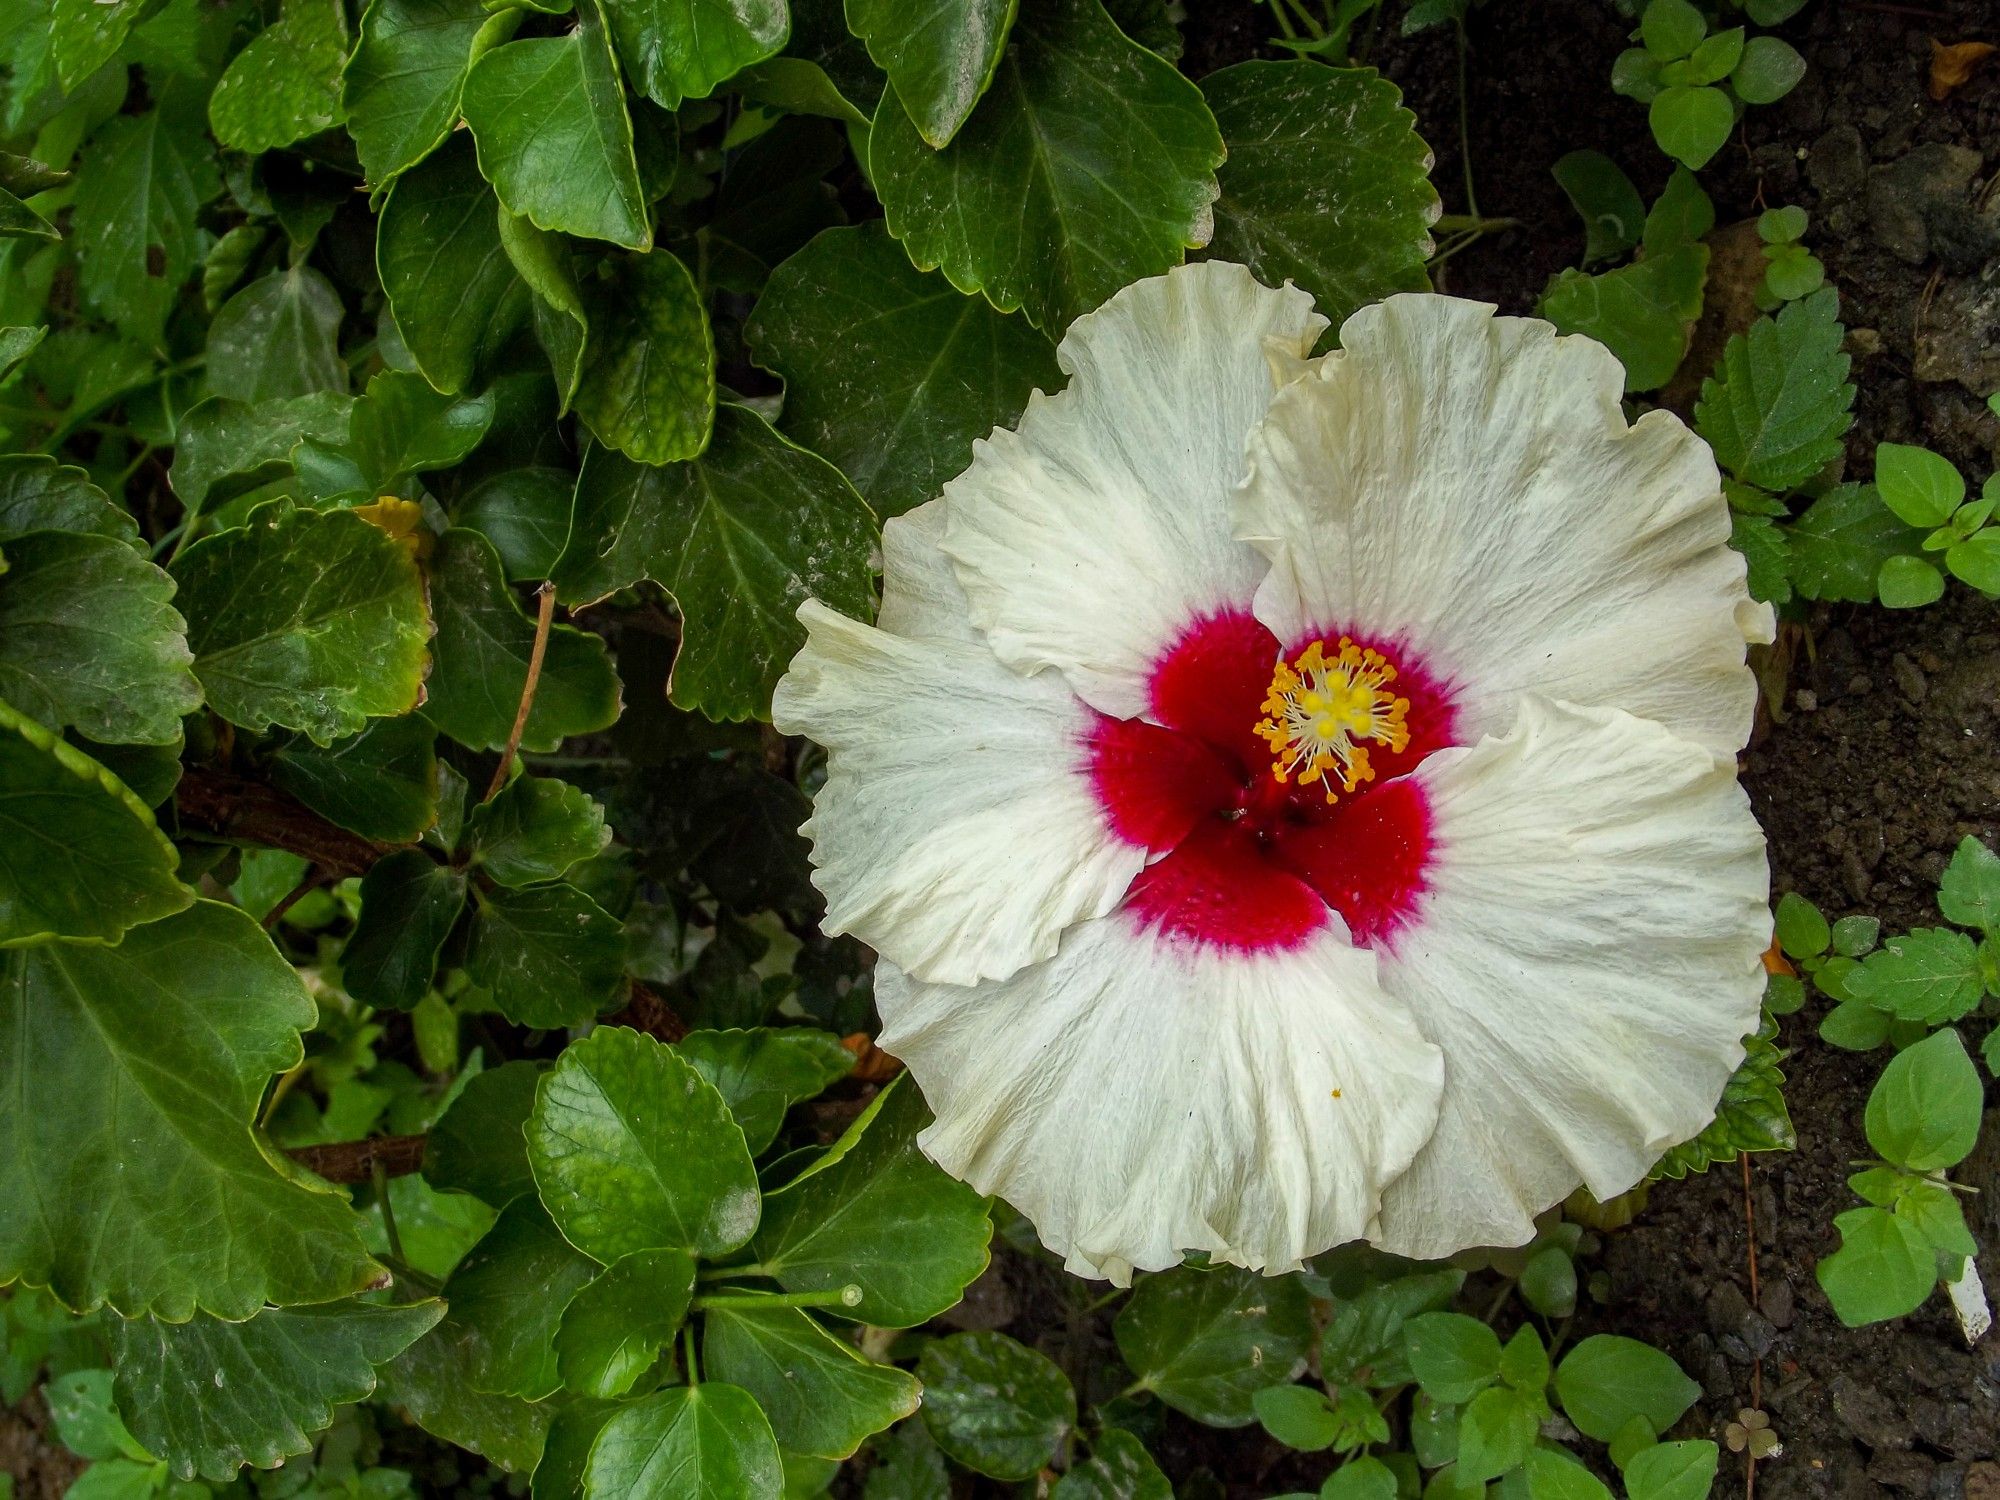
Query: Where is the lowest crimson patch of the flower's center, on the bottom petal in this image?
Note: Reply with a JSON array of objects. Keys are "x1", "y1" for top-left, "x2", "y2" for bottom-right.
[{"x1": 1126, "y1": 820, "x2": 1326, "y2": 952}]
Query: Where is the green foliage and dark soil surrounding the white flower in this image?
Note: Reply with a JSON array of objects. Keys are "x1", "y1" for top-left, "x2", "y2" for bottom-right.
[{"x1": 0, "y1": 0, "x2": 2000, "y2": 1500}]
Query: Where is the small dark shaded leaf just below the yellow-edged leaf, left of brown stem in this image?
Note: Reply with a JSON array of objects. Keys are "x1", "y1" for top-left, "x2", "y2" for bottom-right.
[{"x1": 270, "y1": 714, "x2": 438, "y2": 844}]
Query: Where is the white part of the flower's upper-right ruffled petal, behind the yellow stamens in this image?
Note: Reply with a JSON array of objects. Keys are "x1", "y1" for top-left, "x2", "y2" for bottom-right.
[{"x1": 1238, "y1": 294, "x2": 1772, "y2": 754}]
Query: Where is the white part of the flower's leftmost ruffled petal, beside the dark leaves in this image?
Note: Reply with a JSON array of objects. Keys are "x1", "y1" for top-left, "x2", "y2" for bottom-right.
[{"x1": 772, "y1": 592, "x2": 1144, "y2": 1000}]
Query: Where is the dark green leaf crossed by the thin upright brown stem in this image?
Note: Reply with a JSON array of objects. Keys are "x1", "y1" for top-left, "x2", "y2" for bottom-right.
[{"x1": 424, "y1": 528, "x2": 622, "y2": 750}]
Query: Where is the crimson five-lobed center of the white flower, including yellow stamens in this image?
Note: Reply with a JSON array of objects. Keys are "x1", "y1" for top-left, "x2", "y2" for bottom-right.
[{"x1": 1088, "y1": 612, "x2": 1456, "y2": 952}]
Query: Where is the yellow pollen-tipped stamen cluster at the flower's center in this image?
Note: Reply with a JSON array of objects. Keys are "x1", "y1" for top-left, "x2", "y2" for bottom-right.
[{"x1": 1256, "y1": 636, "x2": 1410, "y2": 802}]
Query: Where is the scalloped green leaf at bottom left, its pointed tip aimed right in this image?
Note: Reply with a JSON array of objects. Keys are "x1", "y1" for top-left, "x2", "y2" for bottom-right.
[{"x1": 116, "y1": 1300, "x2": 444, "y2": 1484}]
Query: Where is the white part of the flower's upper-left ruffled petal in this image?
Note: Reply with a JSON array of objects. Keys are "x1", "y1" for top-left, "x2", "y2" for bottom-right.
[{"x1": 944, "y1": 262, "x2": 1326, "y2": 718}]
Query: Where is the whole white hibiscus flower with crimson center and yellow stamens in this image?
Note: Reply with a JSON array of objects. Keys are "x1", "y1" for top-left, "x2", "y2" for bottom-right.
[{"x1": 776, "y1": 264, "x2": 1770, "y2": 1280}]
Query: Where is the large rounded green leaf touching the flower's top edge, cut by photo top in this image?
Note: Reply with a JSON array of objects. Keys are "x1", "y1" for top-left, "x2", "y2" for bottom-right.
[{"x1": 868, "y1": 0, "x2": 1224, "y2": 330}]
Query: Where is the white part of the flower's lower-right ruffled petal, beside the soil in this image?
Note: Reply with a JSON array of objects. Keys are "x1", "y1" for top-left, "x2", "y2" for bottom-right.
[{"x1": 1374, "y1": 698, "x2": 1770, "y2": 1260}]
